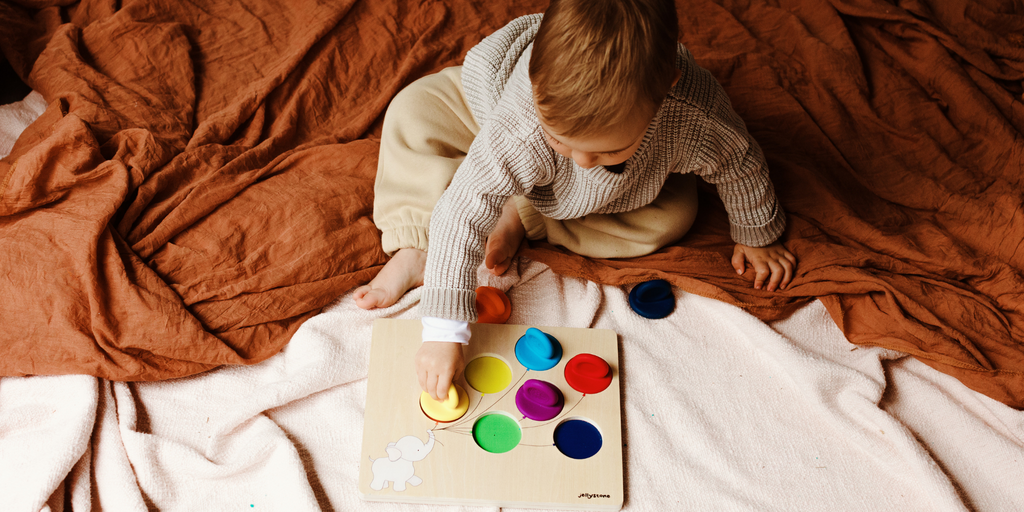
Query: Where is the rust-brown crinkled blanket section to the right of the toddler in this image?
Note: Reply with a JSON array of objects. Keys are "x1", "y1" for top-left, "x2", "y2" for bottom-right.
[{"x1": 525, "y1": 0, "x2": 1024, "y2": 408}]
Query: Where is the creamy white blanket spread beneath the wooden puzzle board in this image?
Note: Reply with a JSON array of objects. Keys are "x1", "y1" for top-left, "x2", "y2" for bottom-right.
[{"x1": 0, "y1": 93, "x2": 1024, "y2": 512}]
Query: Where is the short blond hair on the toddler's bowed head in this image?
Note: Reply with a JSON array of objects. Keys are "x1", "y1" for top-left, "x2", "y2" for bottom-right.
[{"x1": 529, "y1": 0, "x2": 679, "y2": 137}]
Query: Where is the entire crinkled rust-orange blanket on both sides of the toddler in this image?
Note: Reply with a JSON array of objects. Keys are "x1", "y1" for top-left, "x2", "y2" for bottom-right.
[{"x1": 0, "y1": 0, "x2": 1024, "y2": 408}]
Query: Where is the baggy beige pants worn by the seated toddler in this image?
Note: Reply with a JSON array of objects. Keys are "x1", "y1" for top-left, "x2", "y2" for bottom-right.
[{"x1": 374, "y1": 67, "x2": 697, "y2": 258}]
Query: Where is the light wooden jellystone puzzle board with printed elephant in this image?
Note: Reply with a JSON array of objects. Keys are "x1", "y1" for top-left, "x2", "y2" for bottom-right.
[{"x1": 359, "y1": 319, "x2": 624, "y2": 510}]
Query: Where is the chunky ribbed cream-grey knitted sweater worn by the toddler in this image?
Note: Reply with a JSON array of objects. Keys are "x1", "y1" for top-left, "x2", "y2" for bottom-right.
[{"x1": 420, "y1": 14, "x2": 785, "y2": 322}]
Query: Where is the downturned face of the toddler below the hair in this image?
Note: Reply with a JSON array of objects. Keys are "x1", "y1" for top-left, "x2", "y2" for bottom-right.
[{"x1": 537, "y1": 109, "x2": 654, "y2": 169}]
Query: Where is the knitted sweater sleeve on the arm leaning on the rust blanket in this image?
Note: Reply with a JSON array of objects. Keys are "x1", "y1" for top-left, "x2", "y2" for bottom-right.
[{"x1": 696, "y1": 86, "x2": 785, "y2": 247}]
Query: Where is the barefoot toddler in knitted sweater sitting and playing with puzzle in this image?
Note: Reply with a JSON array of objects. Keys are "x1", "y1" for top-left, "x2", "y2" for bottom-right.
[{"x1": 354, "y1": 0, "x2": 796, "y2": 399}]
